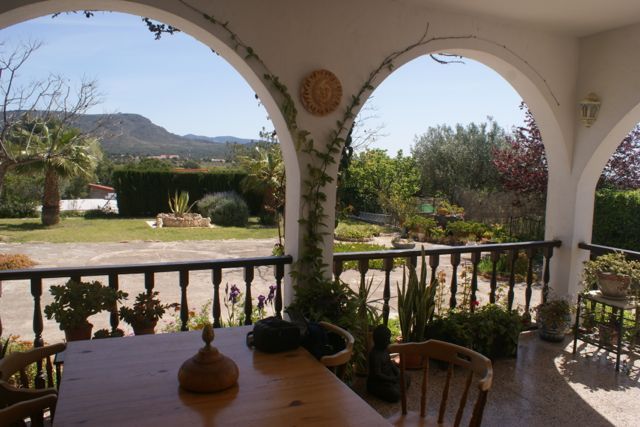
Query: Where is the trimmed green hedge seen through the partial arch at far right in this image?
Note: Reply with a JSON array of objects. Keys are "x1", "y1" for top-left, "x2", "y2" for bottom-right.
[{"x1": 591, "y1": 190, "x2": 640, "y2": 251}]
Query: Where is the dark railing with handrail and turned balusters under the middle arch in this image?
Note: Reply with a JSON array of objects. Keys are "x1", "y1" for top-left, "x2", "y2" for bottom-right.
[{"x1": 333, "y1": 240, "x2": 561, "y2": 324}]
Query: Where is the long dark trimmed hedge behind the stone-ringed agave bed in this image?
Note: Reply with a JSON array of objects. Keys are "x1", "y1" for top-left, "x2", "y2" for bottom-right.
[{"x1": 113, "y1": 168, "x2": 262, "y2": 217}]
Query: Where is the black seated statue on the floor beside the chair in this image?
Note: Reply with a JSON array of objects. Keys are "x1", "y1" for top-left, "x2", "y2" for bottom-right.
[{"x1": 367, "y1": 325, "x2": 400, "y2": 403}]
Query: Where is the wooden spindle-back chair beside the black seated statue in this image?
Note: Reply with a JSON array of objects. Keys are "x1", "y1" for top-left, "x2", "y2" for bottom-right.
[{"x1": 389, "y1": 340, "x2": 493, "y2": 426}]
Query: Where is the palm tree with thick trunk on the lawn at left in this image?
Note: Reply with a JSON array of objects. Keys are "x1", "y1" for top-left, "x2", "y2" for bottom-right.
[{"x1": 20, "y1": 120, "x2": 101, "y2": 226}]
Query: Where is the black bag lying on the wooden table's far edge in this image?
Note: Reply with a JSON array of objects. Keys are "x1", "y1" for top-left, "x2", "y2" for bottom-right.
[{"x1": 247, "y1": 316, "x2": 300, "y2": 353}]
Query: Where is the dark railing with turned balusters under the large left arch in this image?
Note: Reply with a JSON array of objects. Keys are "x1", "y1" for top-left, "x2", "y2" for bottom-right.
[{"x1": 0, "y1": 255, "x2": 292, "y2": 347}]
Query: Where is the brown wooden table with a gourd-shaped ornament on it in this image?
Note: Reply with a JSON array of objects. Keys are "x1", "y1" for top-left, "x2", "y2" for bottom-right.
[{"x1": 54, "y1": 327, "x2": 389, "y2": 427}]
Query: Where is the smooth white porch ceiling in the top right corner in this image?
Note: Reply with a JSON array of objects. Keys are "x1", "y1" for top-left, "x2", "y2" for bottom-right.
[{"x1": 401, "y1": 0, "x2": 640, "y2": 37}]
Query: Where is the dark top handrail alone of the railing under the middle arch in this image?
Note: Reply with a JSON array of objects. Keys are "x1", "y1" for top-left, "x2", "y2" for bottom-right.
[{"x1": 333, "y1": 240, "x2": 562, "y2": 261}]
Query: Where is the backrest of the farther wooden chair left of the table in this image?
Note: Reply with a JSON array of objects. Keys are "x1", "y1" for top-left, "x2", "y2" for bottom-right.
[{"x1": 0, "y1": 343, "x2": 66, "y2": 388}]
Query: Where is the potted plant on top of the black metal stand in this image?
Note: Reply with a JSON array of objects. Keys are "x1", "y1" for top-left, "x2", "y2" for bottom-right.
[{"x1": 583, "y1": 252, "x2": 640, "y2": 299}]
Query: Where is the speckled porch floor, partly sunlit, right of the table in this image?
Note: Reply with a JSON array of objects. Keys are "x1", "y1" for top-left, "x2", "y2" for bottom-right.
[{"x1": 354, "y1": 332, "x2": 640, "y2": 427}]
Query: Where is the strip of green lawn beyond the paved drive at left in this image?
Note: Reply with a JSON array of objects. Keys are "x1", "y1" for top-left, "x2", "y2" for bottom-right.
[{"x1": 0, "y1": 217, "x2": 278, "y2": 243}]
